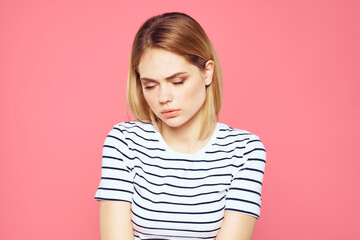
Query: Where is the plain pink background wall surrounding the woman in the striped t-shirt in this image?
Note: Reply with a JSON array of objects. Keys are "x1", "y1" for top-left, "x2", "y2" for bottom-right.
[{"x1": 0, "y1": 0, "x2": 360, "y2": 240}]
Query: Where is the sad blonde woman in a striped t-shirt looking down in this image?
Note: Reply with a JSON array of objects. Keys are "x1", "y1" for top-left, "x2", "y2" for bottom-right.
[{"x1": 95, "y1": 13, "x2": 265, "y2": 240}]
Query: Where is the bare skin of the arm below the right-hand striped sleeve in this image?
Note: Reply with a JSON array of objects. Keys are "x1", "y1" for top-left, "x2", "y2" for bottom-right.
[{"x1": 216, "y1": 211, "x2": 257, "y2": 240}]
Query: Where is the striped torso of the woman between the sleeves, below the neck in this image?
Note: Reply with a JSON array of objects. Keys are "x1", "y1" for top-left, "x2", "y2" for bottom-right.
[{"x1": 119, "y1": 122, "x2": 260, "y2": 240}]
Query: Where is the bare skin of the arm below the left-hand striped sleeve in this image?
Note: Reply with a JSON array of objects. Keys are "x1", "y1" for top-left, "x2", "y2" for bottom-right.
[{"x1": 100, "y1": 200, "x2": 134, "y2": 240}]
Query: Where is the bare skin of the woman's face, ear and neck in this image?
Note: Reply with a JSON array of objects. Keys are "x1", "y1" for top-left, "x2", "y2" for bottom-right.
[{"x1": 138, "y1": 49, "x2": 214, "y2": 153}]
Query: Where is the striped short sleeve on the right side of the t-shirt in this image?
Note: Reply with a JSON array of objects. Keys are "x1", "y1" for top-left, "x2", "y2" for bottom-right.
[{"x1": 225, "y1": 135, "x2": 266, "y2": 218}]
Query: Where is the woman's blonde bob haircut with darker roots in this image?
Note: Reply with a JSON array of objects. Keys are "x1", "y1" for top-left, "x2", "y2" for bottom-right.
[{"x1": 127, "y1": 12, "x2": 222, "y2": 139}]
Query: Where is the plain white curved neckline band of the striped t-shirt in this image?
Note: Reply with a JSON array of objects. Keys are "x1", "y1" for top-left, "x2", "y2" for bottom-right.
[{"x1": 150, "y1": 123, "x2": 220, "y2": 157}]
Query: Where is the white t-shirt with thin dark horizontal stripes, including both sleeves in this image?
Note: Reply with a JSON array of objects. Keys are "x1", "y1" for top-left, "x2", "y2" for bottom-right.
[{"x1": 95, "y1": 121, "x2": 266, "y2": 240}]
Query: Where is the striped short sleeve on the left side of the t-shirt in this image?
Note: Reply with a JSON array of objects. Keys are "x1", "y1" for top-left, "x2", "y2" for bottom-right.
[{"x1": 95, "y1": 125, "x2": 134, "y2": 202}]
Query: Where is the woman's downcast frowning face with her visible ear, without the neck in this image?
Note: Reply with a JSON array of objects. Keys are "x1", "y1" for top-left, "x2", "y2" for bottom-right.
[{"x1": 138, "y1": 49, "x2": 214, "y2": 128}]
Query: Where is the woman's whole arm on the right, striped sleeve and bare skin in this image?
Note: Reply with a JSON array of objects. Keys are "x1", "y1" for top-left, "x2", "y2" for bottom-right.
[{"x1": 216, "y1": 135, "x2": 266, "y2": 240}]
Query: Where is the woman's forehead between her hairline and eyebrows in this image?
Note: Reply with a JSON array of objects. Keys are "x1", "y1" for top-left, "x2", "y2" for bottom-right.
[{"x1": 138, "y1": 48, "x2": 197, "y2": 79}]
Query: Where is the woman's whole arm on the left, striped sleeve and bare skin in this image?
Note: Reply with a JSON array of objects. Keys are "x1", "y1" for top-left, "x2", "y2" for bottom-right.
[{"x1": 95, "y1": 125, "x2": 134, "y2": 240}]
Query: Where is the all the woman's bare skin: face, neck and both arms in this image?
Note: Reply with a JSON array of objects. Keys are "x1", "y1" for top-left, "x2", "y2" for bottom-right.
[{"x1": 100, "y1": 49, "x2": 256, "y2": 240}]
